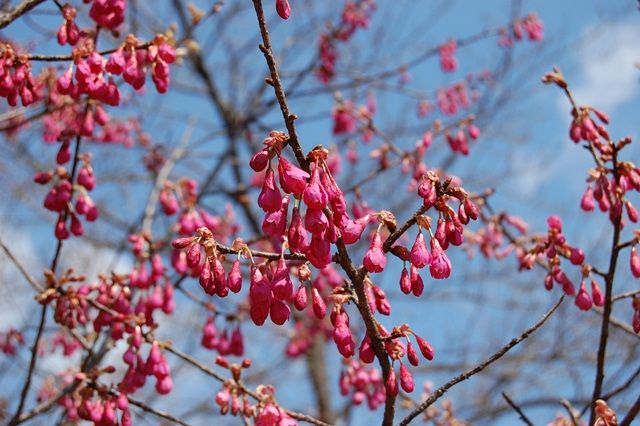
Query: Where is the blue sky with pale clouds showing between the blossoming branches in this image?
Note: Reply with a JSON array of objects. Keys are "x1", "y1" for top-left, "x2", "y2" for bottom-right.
[{"x1": 0, "y1": 0, "x2": 640, "y2": 425}]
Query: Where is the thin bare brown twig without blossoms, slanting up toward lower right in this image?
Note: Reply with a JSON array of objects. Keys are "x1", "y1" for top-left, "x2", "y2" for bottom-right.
[{"x1": 400, "y1": 295, "x2": 564, "y2": 426}]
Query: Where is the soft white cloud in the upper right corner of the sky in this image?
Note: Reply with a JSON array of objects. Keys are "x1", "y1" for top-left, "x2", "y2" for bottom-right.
[{"x1": 562, "y1": 22, "x2": 640, "y2": 113}]
